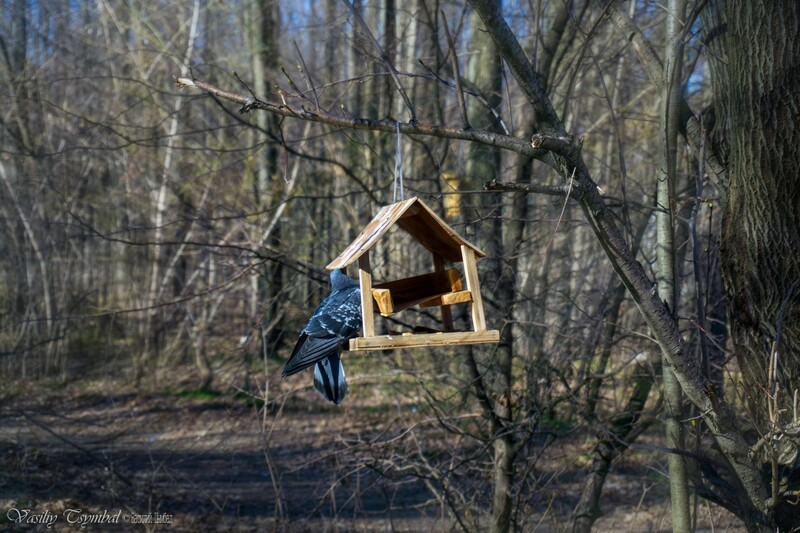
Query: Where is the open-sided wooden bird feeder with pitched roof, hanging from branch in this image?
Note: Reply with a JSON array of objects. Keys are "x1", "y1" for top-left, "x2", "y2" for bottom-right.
[{"x1": 327, "y1": 197, "x2": 500, "y2": 350}]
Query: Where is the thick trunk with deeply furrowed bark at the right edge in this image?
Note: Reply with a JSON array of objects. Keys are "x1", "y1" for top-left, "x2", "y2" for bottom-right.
[{"x1": 704, "y1": 0, "x2": 800, "y2": 530}]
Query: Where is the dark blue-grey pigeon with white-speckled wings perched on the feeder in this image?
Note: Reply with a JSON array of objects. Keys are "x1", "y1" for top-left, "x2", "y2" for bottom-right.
[{"x1": 283, "y1": 270, "x2": 361, "y2": 404}]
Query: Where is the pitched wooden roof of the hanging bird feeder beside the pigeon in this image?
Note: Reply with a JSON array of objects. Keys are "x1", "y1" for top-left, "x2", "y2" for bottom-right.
[{"x1": 327, "y1": 196, "x2": 486, "y2": 270}]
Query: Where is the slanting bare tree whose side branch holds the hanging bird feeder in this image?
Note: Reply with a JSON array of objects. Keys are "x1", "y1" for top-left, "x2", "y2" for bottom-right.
[{"x1": 179, "y1": 0, "x2": 791, "y2": 529}]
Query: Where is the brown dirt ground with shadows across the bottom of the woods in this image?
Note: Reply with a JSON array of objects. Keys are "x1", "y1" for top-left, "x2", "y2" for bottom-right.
[{"x1": 0, "y1": 366, "x2": 743, "y2": 532}]
